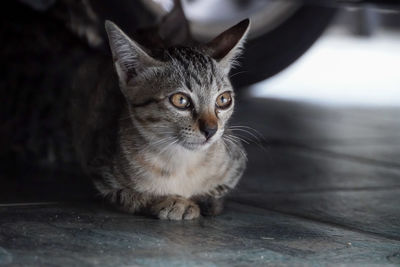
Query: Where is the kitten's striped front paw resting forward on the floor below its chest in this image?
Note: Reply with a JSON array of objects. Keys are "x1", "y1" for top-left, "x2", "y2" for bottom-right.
[{"x1": 151, "y1": 196, "x2": 200, "y2": 220}]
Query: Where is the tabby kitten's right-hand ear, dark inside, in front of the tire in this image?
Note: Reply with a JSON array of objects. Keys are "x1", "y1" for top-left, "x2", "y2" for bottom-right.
[{"x1": 206, "y1": 19, "x2": 250, "y2": 73}]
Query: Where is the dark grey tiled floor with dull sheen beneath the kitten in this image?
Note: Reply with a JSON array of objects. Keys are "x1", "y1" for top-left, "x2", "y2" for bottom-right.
[{"x1": 0, "y1": 99, "x2": 400, "y2": 266}]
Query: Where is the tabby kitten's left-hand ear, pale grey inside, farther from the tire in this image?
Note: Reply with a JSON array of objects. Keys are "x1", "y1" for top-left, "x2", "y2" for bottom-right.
[{"x1": 105, "y1": 20, "x2": 161, "y2": 85}]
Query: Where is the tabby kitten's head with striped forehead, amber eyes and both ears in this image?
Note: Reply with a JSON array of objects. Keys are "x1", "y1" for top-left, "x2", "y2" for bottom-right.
[{"x1": 106, "y1": 20, "x2": 249, "y2": 150}]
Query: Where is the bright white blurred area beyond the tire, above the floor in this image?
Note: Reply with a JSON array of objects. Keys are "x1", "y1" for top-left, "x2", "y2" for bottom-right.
[{"x1": 250, "y1": 5, "x2": 400, "y2": 106}]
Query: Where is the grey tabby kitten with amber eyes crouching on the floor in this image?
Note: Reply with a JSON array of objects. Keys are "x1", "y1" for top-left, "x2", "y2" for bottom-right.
[{"x1": 73, "y1": 20, "x2": 249, "y2": 220}]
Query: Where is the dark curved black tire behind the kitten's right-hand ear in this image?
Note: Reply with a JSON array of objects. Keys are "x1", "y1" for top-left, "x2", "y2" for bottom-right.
[{"x1": 231, "y1": 5, "x2": 336, "y2": 88}]
